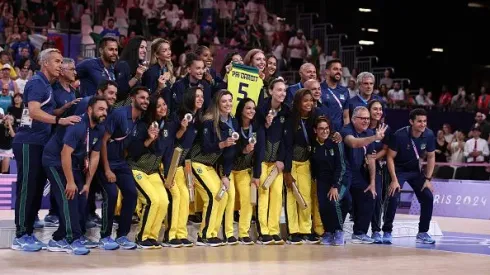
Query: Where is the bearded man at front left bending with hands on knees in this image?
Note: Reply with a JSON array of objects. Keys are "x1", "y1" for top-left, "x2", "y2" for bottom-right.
[{"x1": 43, "y1": 97, "x2": 108, "y2": 255}]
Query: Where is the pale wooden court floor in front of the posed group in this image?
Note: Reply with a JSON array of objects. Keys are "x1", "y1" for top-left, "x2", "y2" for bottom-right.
[{"x1": 0, "y1": 211, "x2": 490, "y2": 275}]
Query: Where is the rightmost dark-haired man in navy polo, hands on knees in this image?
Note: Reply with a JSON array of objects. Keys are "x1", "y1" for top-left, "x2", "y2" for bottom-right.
[{"x1": 383, "y1": 109, "x2": 436, "y2": 244}]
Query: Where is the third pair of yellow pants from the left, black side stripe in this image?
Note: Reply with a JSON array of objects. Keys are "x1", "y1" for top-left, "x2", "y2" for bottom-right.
[{"x1": 192, "y1": 162, "x2": 228, "y2": 239}]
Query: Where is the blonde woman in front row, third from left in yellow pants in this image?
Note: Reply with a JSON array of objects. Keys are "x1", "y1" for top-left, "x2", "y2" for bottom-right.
[{"x1": 191, "y1": 90, "x2": 239, "y2": 247}]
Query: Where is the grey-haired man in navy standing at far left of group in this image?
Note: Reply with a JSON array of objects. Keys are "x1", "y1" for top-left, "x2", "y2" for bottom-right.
[{"x1": 12, "y1": 49, "x2": 80, "y2": 251}]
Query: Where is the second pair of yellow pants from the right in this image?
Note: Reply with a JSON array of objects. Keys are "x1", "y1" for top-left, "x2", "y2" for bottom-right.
[{"x1": 257, "y1": 162, "x2": 284, "y2": 235}]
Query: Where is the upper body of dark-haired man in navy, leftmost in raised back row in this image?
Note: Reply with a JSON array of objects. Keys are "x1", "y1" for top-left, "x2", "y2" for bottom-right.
[{"x1": 76, "y1": 36, "x2": 118, "y2": 97}]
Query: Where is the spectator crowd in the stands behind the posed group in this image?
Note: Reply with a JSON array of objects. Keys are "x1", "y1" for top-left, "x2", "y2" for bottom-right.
[{"x1": 0, "y1": 0, "x2": 490, "y2": 179}]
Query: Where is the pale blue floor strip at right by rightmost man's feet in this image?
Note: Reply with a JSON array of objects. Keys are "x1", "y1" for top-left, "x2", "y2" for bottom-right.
[{"x1": 393, "y1": 232, "x2": 490, "y2": 255}]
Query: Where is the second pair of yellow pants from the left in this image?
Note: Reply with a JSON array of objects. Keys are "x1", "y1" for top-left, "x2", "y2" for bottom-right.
[{"x1": 165, "y1": 166, "x2": 189, "y2": 241}]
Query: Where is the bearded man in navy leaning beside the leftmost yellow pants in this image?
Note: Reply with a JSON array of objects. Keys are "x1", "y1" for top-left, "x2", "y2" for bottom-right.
[{"x1": 97, "y1": 86, "x2": 150, "y2": 249}]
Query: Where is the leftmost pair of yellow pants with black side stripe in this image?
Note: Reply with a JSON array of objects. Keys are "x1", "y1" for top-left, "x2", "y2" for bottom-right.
[{"x1": 133, "y1": 170, "x2": 168, "y2": 241}]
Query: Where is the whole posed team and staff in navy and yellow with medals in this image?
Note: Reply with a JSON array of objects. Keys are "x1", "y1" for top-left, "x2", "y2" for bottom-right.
[{"x1": 12, "y1": 37, "x2": 435, "y2": 255}]
